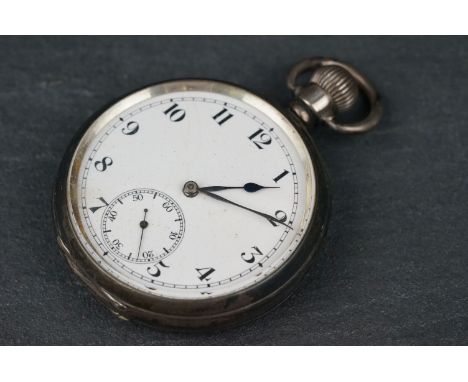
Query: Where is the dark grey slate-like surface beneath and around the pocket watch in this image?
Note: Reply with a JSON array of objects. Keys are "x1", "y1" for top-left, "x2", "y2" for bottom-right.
[{"x1": 0, "y1": 37, "x2": 468, "y2": 345}]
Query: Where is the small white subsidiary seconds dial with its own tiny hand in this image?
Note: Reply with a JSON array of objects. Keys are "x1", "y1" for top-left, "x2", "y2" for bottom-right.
[{"x1": 101, "y1": 188, "x2": 185, "y2": 263}]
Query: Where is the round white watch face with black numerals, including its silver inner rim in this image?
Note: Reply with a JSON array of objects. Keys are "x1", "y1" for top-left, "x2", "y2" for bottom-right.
[{"x1": 67, "y1": 81, "x2": 316, "y2": 300}]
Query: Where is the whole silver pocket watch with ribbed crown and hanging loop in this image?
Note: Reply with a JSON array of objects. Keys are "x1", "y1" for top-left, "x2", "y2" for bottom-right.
[{"x1": 53, "y1": 58, "x2": 382, "y2": 328}]
